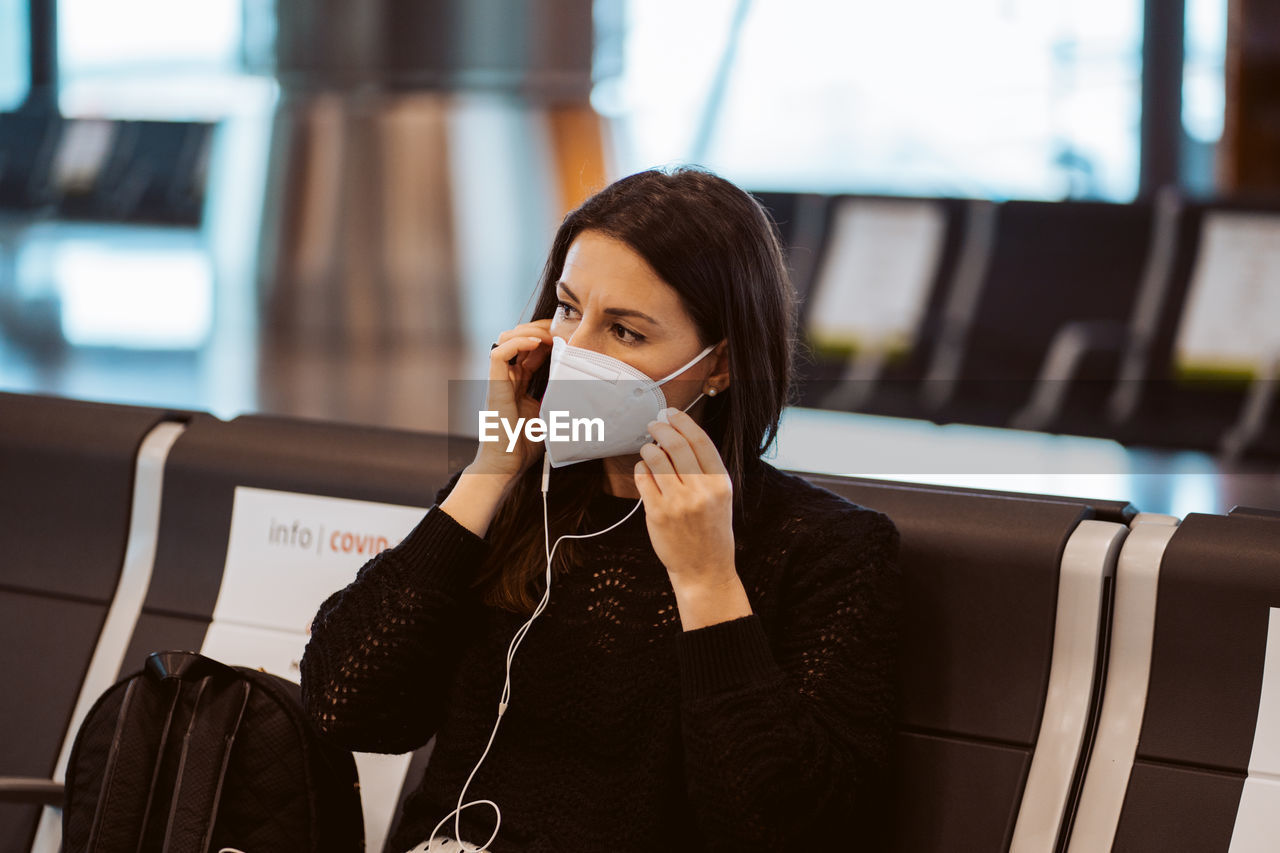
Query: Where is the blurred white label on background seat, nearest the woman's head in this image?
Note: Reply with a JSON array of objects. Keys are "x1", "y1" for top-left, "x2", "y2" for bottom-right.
[{"x1": 809, "y1": 199, "x2": 946, "y2": 351}]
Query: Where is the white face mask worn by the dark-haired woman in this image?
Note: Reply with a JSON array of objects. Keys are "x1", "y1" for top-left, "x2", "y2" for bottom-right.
[{"x1": 539, "y1": 337, "x2": 716, "y2": 467}]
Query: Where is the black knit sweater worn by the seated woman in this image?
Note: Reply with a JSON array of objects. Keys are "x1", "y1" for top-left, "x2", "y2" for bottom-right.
[{"x1": 302, "y1": 462, "x2": 900, "y2": 853}]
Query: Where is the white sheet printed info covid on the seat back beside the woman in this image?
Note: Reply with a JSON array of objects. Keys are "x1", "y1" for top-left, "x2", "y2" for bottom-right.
[{"x1": 214, "y1": 485, "x2": 426, "y2": 630}]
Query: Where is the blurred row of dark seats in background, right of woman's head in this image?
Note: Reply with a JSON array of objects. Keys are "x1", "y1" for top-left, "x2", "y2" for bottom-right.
[{"x1": 756, "y1": 192, "x2": 1280, "y2": 459}]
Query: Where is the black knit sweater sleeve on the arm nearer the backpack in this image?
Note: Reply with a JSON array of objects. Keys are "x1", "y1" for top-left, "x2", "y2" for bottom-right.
[{"x1": 301, "y1": 470, "x2": 489, "y2": 753}]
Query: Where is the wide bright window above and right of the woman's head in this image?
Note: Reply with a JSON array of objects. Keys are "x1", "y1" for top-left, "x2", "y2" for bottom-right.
[{"x1": 604, "y1": 0, "x2": 1142, "y2": 200}]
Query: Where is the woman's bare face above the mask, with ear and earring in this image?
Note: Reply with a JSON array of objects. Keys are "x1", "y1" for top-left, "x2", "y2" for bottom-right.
[{"x1": 550, "y1": 231, "x2": 728, "y2": 409}]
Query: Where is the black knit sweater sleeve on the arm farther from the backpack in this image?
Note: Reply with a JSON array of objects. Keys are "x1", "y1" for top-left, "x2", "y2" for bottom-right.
[{"x1": 678, "y1": 507, "x2": 901, "y2": 852}]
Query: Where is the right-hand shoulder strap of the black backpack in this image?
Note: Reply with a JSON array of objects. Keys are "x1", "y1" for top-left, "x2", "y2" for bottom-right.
[{"x1": 160, "y1": 675, "x2": 252, "y2": 853}]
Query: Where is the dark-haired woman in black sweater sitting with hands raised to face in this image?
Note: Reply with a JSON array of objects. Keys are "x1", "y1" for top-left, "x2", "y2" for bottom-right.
[{"x1": 302, "y1": 169, "x2": 900, "y2": 853}]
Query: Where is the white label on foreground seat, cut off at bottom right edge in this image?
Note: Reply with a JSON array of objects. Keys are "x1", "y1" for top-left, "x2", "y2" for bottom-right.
[{"x1": 1229, "y1": 607, "x2": 1280, "y2": 853}]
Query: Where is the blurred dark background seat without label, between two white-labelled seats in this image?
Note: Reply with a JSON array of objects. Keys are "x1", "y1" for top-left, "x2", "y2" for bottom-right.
[{"x1": 923, "y1": 201, "x2": 1155, "y2": 432}]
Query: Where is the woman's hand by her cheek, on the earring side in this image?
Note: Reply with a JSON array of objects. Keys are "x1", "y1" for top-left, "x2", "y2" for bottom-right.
[{"x1": 635, "y1": 409, "x2": 741, "y2": 598}]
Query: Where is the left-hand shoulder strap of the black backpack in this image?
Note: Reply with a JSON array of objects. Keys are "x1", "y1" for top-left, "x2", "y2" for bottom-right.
[{"x1": 84, "y1": 678, "x2": 180, "y2": 853}]
